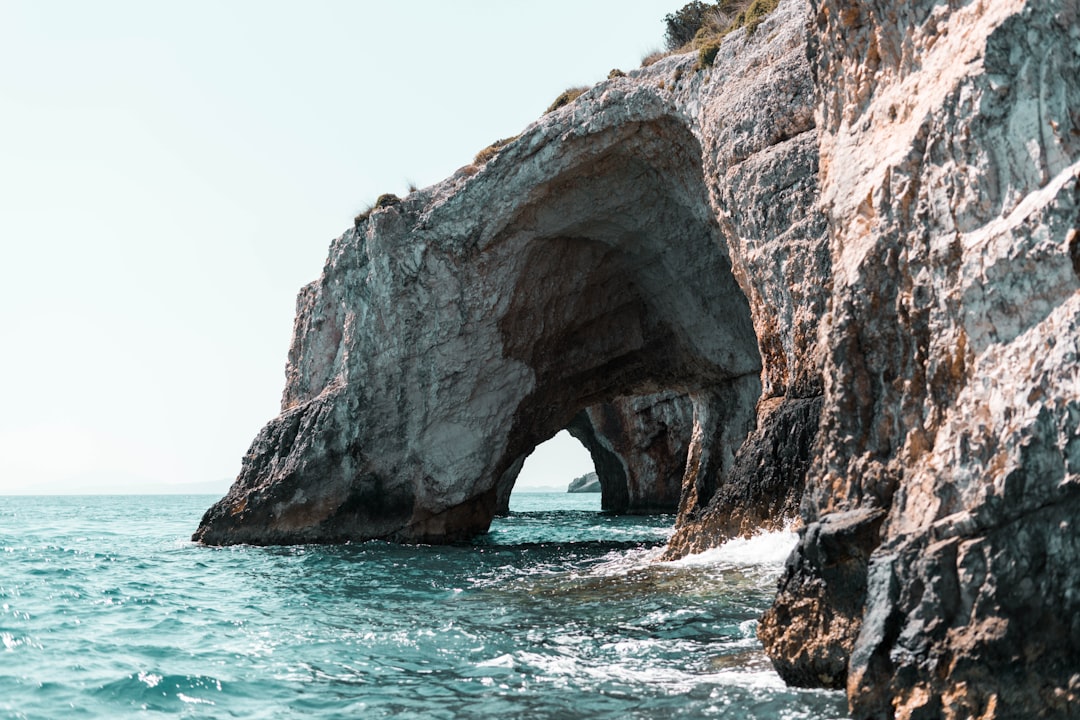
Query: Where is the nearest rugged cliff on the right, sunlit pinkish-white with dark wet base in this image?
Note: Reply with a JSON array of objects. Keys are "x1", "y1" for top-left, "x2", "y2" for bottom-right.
[{"x1": 761, "y1": 0, "x2": 1080, "y2": 718}]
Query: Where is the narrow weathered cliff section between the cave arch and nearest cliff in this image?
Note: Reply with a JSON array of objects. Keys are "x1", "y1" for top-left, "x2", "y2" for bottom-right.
[{"x1": 667, "y1": 2, "x2": 831, "y2": 558}]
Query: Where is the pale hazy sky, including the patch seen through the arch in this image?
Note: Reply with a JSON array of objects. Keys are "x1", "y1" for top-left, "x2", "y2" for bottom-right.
[{"x1": 0, "y1": 0, "x2": 683, "y2": 493}]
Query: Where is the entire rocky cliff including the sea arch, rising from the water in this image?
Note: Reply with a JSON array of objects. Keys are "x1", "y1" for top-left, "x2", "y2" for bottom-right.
[{"x1": 195, "y1": 0, "x2": 1080, "y2": 719}]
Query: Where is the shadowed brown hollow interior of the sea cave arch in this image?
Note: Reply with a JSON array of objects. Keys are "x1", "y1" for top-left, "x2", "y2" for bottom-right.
[{"x1": 473, "y1": 123, "x2": 760, "y2": 533}]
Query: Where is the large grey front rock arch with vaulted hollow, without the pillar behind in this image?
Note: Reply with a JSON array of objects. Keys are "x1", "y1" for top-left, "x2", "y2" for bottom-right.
[{"x1": 197, "y1": 94, "x2": 761, "y2": 544}]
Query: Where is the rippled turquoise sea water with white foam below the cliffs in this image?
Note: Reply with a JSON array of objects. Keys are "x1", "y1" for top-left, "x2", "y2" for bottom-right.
[{"x1": 0, "y1": 493, "x2": 845, "y2": 720}]
